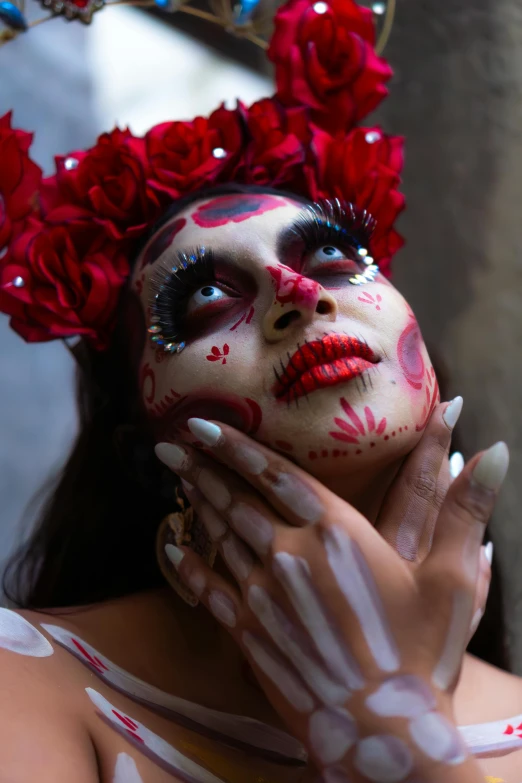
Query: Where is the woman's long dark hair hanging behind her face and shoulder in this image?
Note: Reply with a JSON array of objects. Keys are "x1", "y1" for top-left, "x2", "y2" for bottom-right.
[{"x1": 3, "y1": 184, "x2": 506, "y2": 668}]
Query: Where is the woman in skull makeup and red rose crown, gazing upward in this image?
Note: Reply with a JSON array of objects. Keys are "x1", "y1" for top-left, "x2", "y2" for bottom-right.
[{"x1": 0, "y1": 2, "x2": 522, "y2": 783}]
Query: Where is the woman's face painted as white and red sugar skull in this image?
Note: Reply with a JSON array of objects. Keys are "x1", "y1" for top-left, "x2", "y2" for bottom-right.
[{"x1": 132, "y1": 194, "x2": 438, "y2": 477}]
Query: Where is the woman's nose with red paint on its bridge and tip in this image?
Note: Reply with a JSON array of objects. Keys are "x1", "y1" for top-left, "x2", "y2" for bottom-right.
[{"x1": 263, "y1": 264, "x2": 338, "y2": 342}]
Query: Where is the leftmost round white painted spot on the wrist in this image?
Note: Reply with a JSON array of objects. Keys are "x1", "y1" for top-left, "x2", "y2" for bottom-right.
[{"x1": 308, "y1": 707, "x2": 358, "y2": 764}]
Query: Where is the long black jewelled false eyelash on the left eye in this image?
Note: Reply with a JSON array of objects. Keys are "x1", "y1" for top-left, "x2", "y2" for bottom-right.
[{"x1": 149, "y1": 247, "x2": 214, "y2": 353}]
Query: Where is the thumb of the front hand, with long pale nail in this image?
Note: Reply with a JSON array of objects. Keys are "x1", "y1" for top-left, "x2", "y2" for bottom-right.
[{"x1": 417, "y1": 442, "x2": 509, "y2": 689}]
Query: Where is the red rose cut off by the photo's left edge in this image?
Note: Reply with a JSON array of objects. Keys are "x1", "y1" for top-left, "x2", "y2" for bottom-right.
[{"x1": 0, "y1": 113, "x2": 42, "y2": 250}]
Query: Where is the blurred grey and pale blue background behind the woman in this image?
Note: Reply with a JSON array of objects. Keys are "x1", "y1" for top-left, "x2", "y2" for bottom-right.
[{"x1": 0, "y1": 0, "x2": 522, "y2": 674}]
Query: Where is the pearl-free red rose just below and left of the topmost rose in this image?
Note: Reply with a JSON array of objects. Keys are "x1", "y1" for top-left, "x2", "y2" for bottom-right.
[{"x1": 242, "y1": 98, "x2": 311, "y2": 192}]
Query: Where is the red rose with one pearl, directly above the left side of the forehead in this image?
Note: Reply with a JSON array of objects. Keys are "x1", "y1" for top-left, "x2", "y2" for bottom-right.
[{"x1": 145, "y1": 105, "x2": 243, "y2": 198}]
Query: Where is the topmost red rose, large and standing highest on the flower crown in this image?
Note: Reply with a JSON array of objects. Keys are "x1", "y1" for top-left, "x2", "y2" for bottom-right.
[{"x1": 268, "y1": 0, "x2": 391, "y2": 132}]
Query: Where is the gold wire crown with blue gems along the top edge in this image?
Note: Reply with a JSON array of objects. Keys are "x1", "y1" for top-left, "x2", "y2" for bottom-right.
[{"x1": 0, "y1": 0, "x2": 396, "y2": 54}]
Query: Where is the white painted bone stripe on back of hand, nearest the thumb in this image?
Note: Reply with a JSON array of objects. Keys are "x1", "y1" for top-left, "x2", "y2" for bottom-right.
[{"x1": 323, "y1": 526, "x2": 400, "y2": 672}]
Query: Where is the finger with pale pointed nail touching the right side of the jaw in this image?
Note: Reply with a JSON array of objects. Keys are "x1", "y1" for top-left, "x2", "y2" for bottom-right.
[{"x1": 376, "y1": 397, "x2": 462, "y2": 562}]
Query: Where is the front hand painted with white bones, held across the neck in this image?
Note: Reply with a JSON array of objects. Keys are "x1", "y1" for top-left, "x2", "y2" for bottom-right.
[{"x1": 157, "y1": 419, "x2": 508, "y2": 783}]
